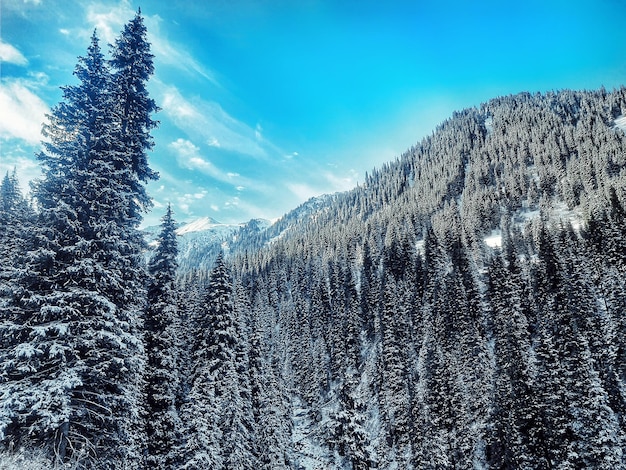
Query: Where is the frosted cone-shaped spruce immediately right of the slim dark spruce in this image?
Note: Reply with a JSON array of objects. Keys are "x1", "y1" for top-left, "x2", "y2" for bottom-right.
[{"x1": 183, "y1": 253, "x2": 255, "y2": 470}]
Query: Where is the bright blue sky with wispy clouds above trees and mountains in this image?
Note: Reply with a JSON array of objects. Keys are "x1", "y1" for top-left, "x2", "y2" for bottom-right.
[{"x1": 0, "y1": 0, "x2": 626, "y2": 225}]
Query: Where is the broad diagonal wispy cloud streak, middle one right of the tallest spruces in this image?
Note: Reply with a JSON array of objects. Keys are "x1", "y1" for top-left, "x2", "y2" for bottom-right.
[{"x1": 160, "y1": 86, "x2": 267, "y2": 158}]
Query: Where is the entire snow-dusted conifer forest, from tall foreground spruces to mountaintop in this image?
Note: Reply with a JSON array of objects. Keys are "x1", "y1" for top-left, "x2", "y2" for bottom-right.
[{"x1": 0, "y1": 12, "x2": 626, "y2": 470}]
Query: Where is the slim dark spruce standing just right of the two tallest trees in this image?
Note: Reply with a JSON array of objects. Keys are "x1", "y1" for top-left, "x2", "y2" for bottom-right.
[{"x1": 144, "y1": 205, "x2": 182, "y2": 468}]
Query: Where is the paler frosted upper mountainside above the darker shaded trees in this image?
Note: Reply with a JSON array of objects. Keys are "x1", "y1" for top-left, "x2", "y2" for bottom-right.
[{"x1": 233, "y1": 89, "x2": 626, "y2": 264}]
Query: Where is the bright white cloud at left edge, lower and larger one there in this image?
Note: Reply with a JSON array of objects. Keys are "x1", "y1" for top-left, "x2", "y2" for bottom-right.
[{"x1": 0, "y1": 81, "x2": 48, "y2": 145}]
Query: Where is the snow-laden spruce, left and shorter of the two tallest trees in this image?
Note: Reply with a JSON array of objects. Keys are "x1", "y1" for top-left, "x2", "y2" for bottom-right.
[{"x1": 2, "y1": 33, "x2": 122, "y2": 460}]
